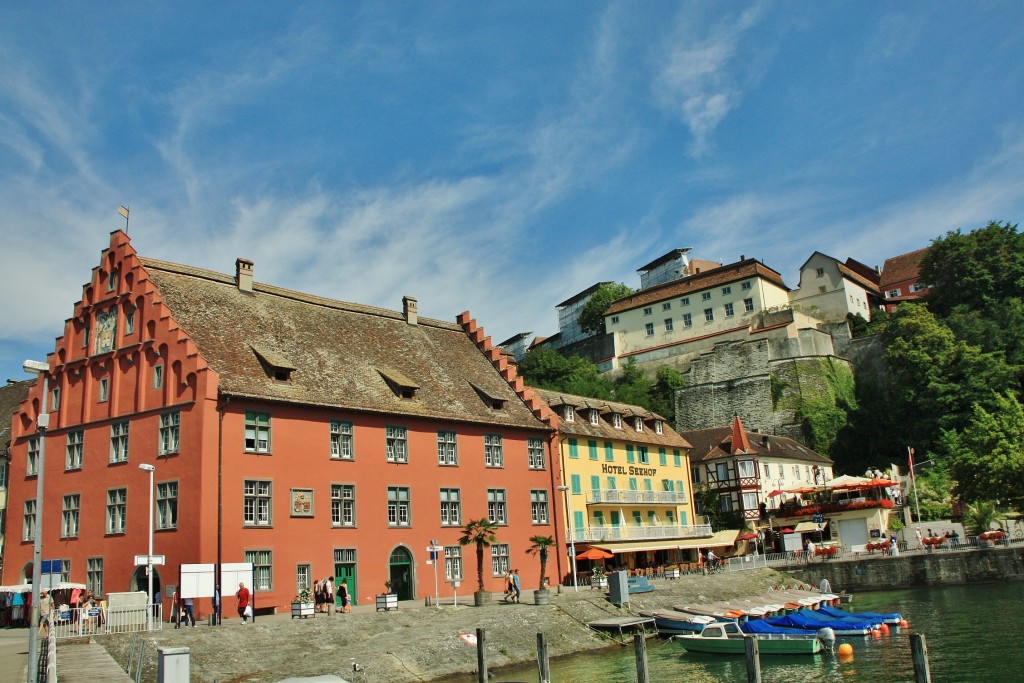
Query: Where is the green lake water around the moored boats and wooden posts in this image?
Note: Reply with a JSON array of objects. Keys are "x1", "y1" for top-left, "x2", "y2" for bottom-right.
[{"x1": 473, "y1": 583, "x2": 1024, "y2": 683}]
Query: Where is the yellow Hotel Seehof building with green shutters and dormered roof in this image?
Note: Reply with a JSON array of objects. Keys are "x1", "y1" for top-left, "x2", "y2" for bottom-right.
[{"x1": 535, "y1": 389, "x2": 720, "y2": 572}]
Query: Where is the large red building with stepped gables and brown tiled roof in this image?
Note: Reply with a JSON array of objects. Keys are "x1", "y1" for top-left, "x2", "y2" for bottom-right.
[{"x1": 2, "y1": 230, "x2": 560, "y2": 613}]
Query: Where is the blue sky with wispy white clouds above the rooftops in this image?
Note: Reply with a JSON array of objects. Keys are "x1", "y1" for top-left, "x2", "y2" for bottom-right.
[{"x1": 0, "y1": 1, "x2": 1024, "y2": 380}]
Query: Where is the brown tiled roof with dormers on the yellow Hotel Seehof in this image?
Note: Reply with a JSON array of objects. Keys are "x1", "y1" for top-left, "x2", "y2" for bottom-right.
[{"x1": 534, "y1": 388, "x2": 690, "y2": 449}]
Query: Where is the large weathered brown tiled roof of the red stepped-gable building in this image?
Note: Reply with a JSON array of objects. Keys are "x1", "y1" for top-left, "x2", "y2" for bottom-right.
[{"x1": 141, "y1": 258, "x2": 548, "y2": 430}]
